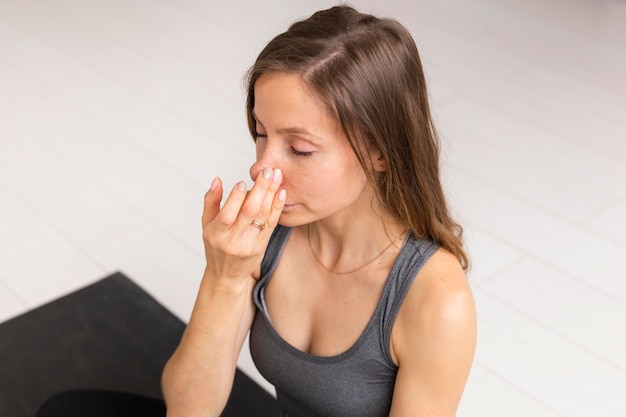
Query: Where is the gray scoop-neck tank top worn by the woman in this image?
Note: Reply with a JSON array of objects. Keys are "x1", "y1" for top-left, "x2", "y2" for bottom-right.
[{"x1": 250, "y1": 226, "x2": 438, "y2": 417}]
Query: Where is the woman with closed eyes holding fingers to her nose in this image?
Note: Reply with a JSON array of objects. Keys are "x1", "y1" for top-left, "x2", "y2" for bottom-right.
[{"x1": 163, "y1": 6, "x2": 476, "y2": 417}]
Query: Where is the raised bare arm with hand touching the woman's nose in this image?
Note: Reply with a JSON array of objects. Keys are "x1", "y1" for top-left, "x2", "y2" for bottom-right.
[{"x1": 162, "y1": 170, "x2": 285, "y2": 417}]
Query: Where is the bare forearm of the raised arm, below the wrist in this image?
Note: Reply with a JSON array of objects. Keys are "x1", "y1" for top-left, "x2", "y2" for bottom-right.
[{"x1": 162, "y1": 276, "x2": 255, "y2": 417}]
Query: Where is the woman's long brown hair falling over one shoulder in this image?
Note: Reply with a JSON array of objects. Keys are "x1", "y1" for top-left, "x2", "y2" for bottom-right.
[{"x1": 246, "y1": 6, "x2": 469, "y2": 269}]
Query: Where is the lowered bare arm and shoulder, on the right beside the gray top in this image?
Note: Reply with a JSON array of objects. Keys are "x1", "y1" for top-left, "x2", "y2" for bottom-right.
[{"x1": 390, "y1": 250, "x2": 476, "y2": 417}]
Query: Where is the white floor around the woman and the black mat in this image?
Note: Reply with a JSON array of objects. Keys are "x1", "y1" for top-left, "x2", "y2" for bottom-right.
[{"x1": 0, "y1": 0, "x2": 626, "y2": 417}]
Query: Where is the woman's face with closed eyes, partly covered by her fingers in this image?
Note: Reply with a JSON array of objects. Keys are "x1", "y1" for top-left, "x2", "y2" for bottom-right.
[{"x1": 250, "y1": 73, "x2": 373, "y2": 226}]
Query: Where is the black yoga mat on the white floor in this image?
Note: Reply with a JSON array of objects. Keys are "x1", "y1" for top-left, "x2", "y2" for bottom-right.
[{"x1": 0, "y1": 273, "x2": 281, "y2": 417}]
